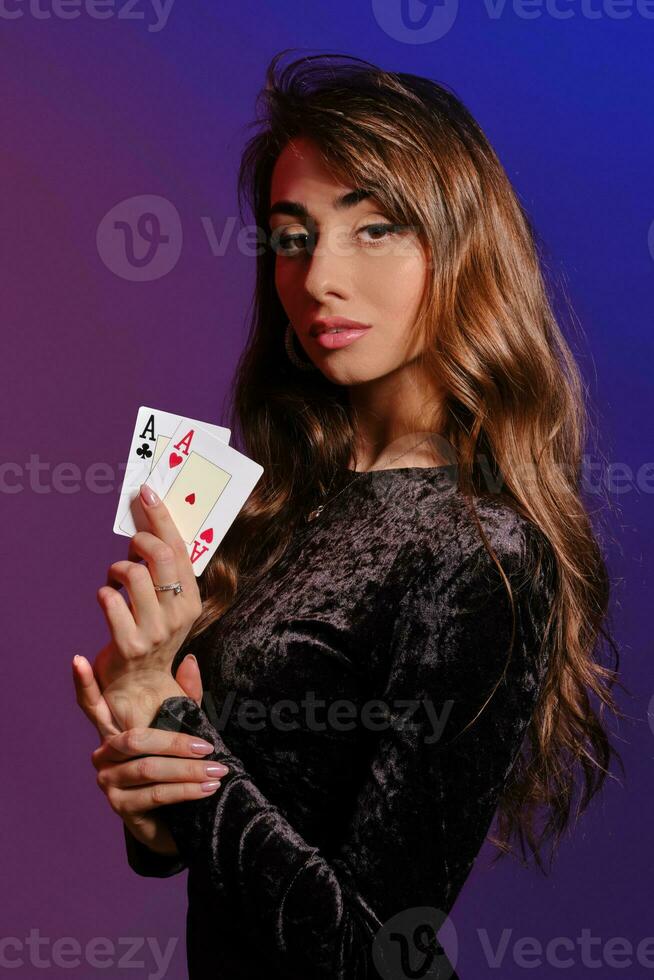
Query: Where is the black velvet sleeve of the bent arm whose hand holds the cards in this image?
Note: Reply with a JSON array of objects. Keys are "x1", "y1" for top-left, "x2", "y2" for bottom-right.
[{"x1": 153, "y1": 542, "x2": 553, "y2": 980}]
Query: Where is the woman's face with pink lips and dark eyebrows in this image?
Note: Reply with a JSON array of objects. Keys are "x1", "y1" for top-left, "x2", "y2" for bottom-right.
[{"x1": 270, "y1": 138, "x2": 427, "y2": 385}]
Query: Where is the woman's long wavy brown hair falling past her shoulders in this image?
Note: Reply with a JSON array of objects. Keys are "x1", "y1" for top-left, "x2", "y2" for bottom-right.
[{"x1": 181, "y1": 49, "x2": 623, "y2": 870}]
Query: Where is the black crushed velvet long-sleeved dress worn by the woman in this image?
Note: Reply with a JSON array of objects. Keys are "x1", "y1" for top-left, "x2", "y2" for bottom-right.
[{"x1": 125, "y1": 464, "x2": 556, "y2": 980}]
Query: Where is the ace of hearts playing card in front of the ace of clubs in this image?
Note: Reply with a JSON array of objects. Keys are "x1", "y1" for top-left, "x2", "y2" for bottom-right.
[{"x1": 144, "y1": 419, "x2": 263, "y2": 576}]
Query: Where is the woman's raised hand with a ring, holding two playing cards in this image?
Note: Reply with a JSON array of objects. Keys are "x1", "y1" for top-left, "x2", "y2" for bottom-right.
[{"x1": 93, "y1": 486, "x2": 202, "y2": 729}]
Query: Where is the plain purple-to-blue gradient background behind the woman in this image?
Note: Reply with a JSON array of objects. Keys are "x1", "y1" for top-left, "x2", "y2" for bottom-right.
[{"x1": 0, "y1": 0, "x2": 654, "y2": 980}]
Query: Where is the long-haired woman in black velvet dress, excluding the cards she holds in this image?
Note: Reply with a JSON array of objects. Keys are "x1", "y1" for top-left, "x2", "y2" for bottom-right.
[{"x1": 76, "y1": 55, "x2": 617, "y2": 978}]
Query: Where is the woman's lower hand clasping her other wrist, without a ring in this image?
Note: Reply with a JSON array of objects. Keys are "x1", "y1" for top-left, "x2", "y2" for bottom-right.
[{"x1": 73, "y1": 656, "x2": 228, "y2": 855}]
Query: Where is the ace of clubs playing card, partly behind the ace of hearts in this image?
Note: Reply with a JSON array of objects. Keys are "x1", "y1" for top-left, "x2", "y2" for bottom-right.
[{"x1": 113, "y1": 405, "x2": 231, "y2": 538}]
